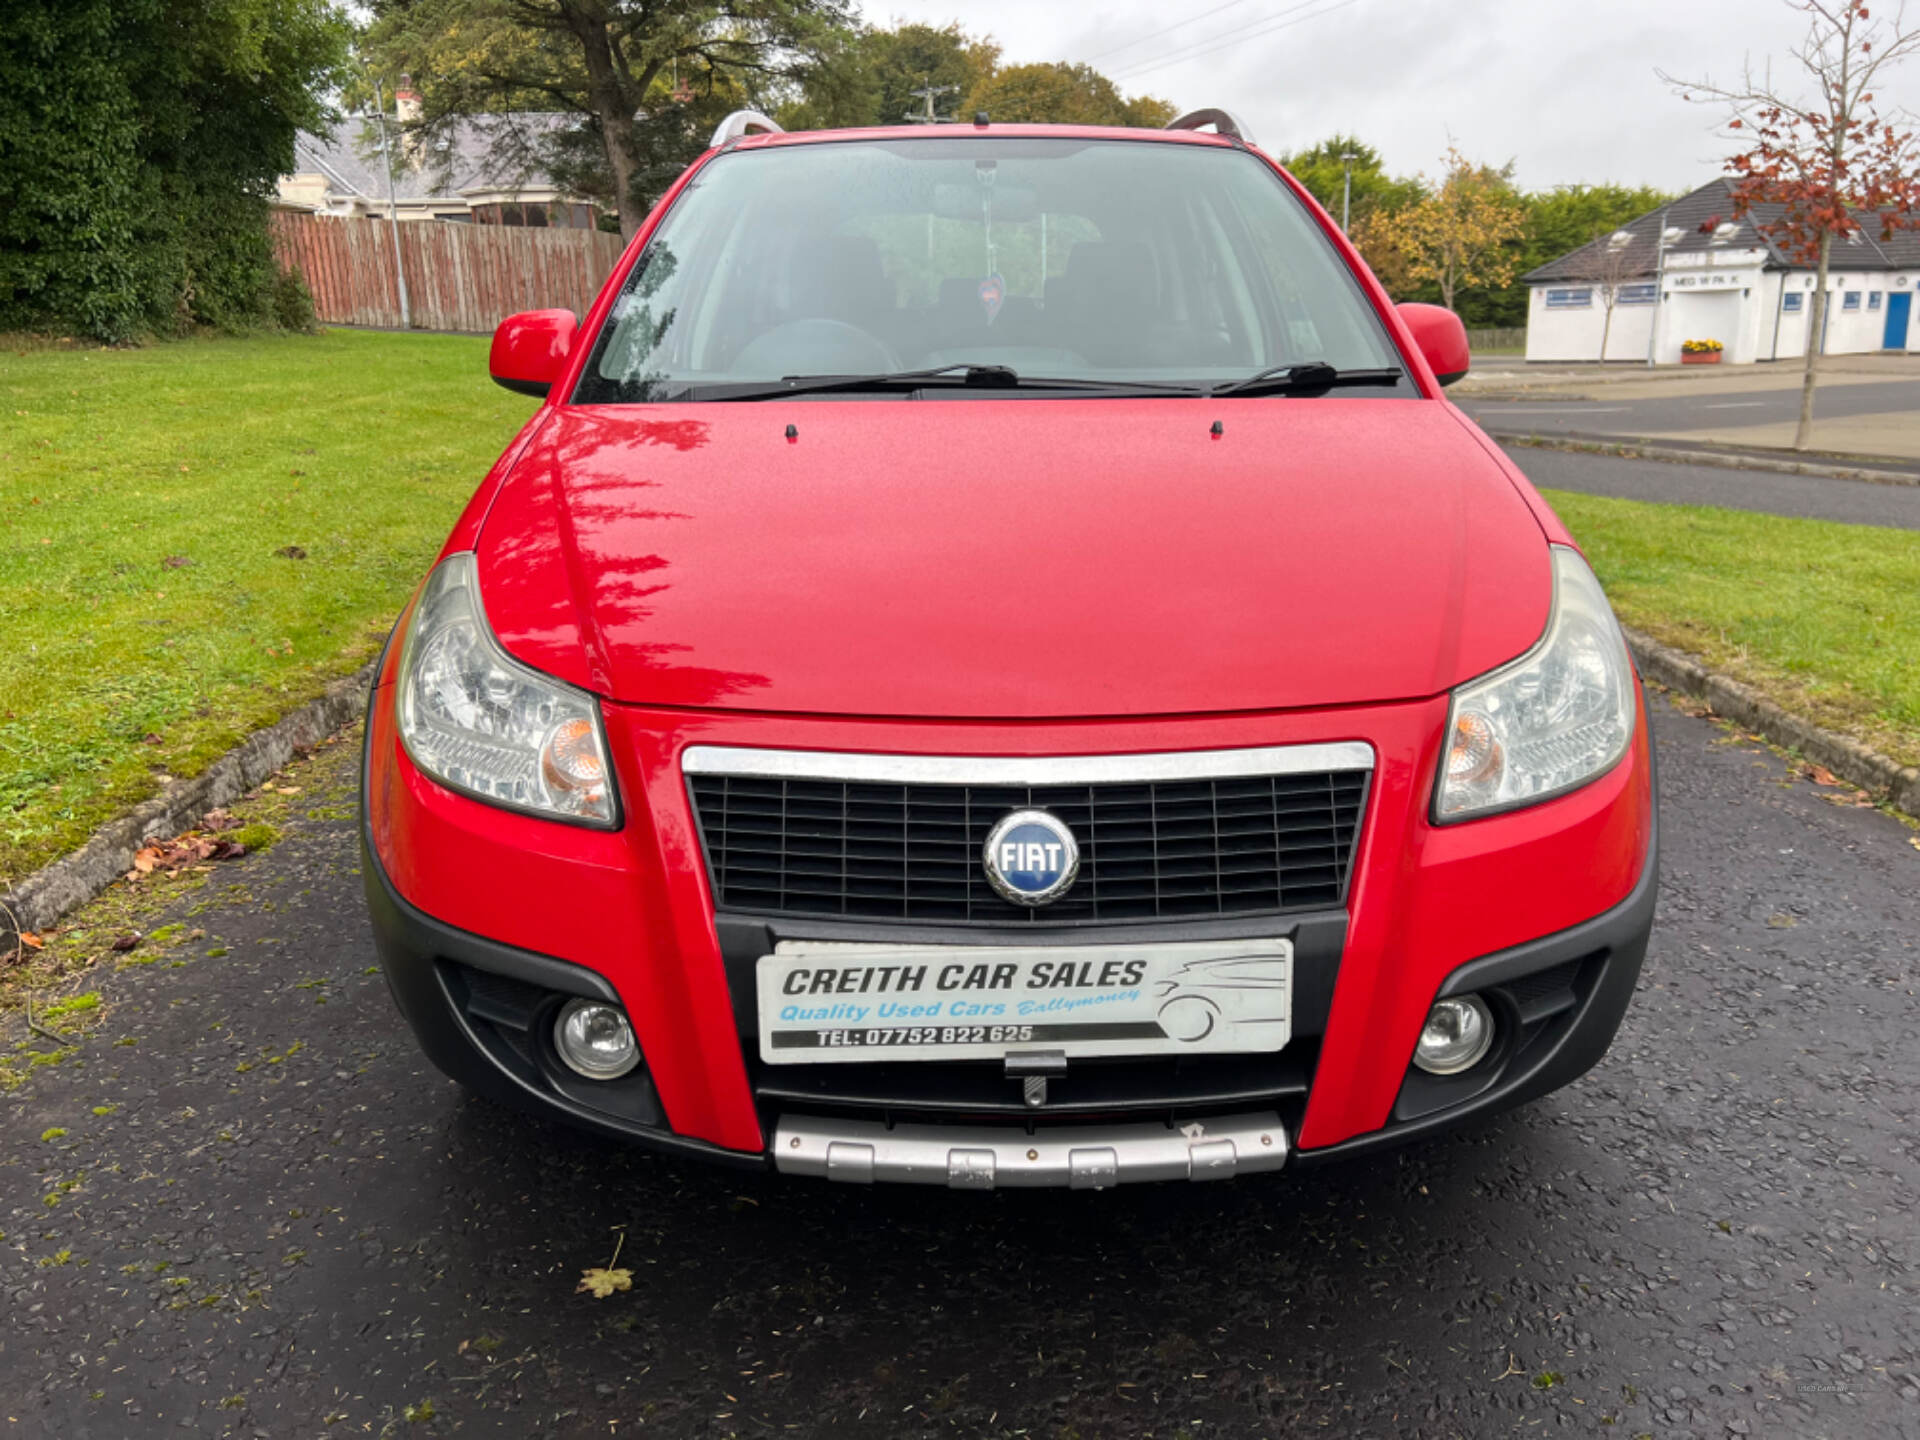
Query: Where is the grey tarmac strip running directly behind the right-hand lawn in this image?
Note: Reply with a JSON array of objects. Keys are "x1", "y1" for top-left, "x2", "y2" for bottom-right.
[{"x1": 1505, "y1": 445, "x2": 1920, "y2": 530}]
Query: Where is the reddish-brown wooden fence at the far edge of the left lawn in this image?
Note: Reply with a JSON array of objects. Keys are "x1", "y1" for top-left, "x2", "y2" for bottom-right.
[{"x1": 273, "y1": 211, "x2": 624, "y2": 332}]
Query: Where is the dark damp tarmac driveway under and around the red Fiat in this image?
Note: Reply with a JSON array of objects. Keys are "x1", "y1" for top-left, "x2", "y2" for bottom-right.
[{"x1": 0, "y1": 701, "x2": 1920, "y2": 1440}]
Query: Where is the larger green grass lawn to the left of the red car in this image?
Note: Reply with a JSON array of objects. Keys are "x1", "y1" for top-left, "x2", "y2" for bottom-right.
[{"x1": 0, "y1": 330, "x2": 534, "y2": 889}]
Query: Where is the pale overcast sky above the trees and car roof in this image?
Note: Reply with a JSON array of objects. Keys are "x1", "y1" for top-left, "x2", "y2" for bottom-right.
[{"x1": 860, "y1": 0, "x2": 1920, "y2": 190}]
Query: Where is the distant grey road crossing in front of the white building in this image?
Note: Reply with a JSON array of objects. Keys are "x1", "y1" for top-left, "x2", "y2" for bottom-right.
[{"x1": 1461, "y1": 380, "x2": 1920, "y2": 436}]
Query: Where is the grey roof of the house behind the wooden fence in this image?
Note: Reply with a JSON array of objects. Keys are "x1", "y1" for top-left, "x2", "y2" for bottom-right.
[{"x1": 294, "y1": 111, "x2": 578, "y2": 200}]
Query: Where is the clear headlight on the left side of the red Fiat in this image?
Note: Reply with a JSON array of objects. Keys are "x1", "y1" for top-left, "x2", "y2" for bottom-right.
[{"x1": 399, "y1": 551, "x2": 614, "y2": 828}]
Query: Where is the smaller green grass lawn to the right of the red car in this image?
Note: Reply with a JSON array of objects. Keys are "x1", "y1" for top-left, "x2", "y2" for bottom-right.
[{"x1": 1546, "y1": 490, "x2": 1920, "y2": 764}]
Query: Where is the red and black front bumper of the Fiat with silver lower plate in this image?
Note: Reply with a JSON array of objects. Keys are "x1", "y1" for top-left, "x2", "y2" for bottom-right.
[{"x1": 363, "y1": 660, "x2": 1657, "y2": 1185}]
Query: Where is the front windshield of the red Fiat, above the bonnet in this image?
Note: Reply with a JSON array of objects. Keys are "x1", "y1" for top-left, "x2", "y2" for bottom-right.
[{"x1": 574, "y1": 134, "x2": 1411, "y2": 403}]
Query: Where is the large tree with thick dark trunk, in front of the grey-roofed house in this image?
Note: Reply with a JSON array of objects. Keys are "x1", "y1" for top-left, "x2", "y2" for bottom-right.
[{"x1": 367, "y1": 0, "x2": 852, "y2": 234}]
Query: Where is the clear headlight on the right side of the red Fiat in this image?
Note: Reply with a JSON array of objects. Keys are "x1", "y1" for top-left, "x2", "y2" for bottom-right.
[{"x1": 1434, "y1": 545, "x2": 1638, "y2": 820}]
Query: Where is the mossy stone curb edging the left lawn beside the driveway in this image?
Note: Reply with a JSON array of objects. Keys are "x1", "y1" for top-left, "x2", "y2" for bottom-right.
[{"x1": 0, "y1": 664, "x2": 374, "y2": 945}]
